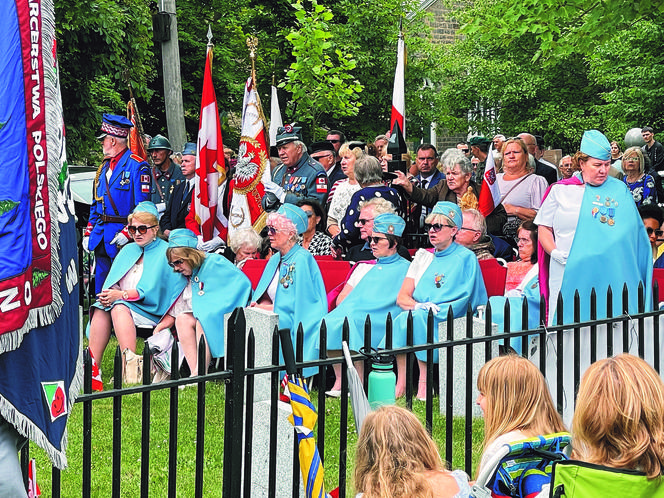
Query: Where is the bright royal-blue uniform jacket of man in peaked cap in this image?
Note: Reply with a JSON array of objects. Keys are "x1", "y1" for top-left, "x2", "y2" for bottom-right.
[{"x1": 89, "y1": 149, "x2": 152, "y2": 258}]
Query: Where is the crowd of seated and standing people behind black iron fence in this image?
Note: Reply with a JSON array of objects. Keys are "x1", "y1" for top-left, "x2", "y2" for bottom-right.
[{"x1": 83, "y1": 115, "x2": 664, "y2": 390}]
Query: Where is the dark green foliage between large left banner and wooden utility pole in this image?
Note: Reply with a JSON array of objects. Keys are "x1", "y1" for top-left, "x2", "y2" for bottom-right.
[{"x1": 55, "y1": 0, "x2": 154, "y2": 164}]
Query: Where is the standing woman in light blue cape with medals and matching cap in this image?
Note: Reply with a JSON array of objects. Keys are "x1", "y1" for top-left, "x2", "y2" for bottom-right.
[{"x1": 535, "y1": 130, "x2": 652, "y2": 422}]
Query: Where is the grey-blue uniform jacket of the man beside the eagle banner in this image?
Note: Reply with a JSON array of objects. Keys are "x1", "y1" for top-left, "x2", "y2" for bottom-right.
[{"x1": 272, "y1": 152, "x2": 328, "y2": 206}]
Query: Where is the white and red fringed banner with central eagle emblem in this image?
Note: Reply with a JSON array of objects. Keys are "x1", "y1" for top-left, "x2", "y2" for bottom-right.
[{"x1": 228, "y1": 77, "x2": 270, "y2": 236}]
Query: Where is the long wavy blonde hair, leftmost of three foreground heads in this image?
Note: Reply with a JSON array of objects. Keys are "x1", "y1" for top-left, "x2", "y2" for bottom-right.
[{"x1": 354, "y1": 406, "x2": 445, "y2": 498}]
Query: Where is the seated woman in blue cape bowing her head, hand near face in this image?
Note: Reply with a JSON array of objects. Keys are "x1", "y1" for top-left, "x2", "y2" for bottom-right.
[{"x1": 155, "y1": 228, "x2": 251, "y2": 375}]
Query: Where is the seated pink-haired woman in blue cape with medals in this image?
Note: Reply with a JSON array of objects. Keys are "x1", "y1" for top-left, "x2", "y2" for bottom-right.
[{"x1": 251, "y1": 204, "x2": 327, "y2": 377}]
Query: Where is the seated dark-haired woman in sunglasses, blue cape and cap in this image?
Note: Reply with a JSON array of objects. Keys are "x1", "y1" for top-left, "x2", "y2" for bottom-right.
[{"x1": 324, "y1": 213, "x2": 410, "y2": 396}]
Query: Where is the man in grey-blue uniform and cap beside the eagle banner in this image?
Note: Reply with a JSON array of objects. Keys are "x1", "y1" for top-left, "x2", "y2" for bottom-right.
[{"x1": 263, "y1": 125, "x2": 328, "y2": 206}]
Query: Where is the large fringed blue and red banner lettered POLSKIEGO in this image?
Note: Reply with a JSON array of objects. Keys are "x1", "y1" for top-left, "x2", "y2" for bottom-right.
[{"x1": 0, "y1": 0, "x2": 83, "y2": 468}]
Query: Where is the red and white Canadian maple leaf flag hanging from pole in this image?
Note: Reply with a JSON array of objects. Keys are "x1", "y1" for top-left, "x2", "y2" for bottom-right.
[{"x1": 191, "y1": 48, "x2": 228, "y2": 241}]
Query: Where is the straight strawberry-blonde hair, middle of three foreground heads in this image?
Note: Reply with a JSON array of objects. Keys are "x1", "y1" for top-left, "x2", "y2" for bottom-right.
[{"x1": 477, "y1": 354, "x2": 567, "y2": 449}]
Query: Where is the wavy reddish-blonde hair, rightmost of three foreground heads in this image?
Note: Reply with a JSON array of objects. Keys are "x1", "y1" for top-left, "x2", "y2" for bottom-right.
[{"x1": 572, "y1": 354, "x2": 664, "y2": 479}]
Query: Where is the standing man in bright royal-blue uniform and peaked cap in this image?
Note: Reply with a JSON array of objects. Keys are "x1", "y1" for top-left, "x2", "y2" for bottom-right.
[{"x1": 83, "y1": 114, "x2": 152, "y2": 293}]
